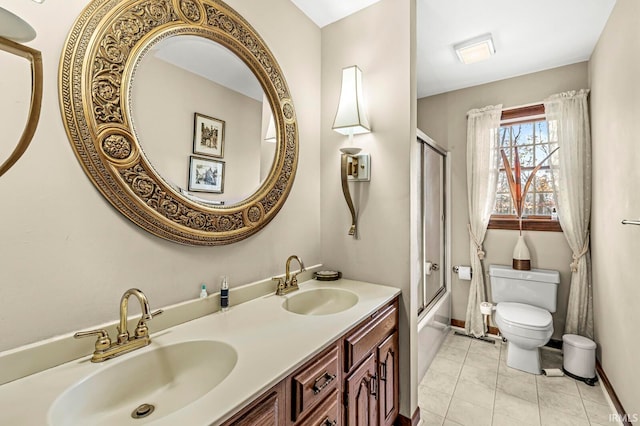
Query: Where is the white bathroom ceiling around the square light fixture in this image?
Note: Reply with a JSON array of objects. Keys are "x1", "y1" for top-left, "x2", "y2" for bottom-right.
[{"x1": 291, "y1": 0, "x2": 615, "y2": 98}]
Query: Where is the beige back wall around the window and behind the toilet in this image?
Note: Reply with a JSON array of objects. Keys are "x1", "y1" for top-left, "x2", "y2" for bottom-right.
[{"x1": 418, "y1": 62, "x2": 588, "y2": 338}]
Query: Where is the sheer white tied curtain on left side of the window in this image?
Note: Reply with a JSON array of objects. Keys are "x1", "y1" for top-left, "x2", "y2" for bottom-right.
[{"x1": 465, "y1": 105, "x2": 502, "y2": 337}]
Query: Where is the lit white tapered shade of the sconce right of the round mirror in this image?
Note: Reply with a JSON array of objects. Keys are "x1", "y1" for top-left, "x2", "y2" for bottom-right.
[{"x1": 333, "y1": 65, "x2": 371, "y2": 136}]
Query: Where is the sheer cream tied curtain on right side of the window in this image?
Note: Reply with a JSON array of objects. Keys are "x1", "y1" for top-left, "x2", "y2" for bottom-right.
[{"x1": 544, "y1": 90, "x2": 593, "y2": 339}]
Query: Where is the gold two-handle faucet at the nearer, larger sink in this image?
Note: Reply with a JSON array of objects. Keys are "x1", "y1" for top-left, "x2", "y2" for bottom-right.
[{"x1": 74, "y1": 288, "x2": 162, "y2": 362}]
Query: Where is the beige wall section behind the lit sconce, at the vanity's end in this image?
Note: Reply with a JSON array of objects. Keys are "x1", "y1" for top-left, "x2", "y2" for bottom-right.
[{"x1": 321, "y1": 0, "x2": 417, "y2": 416}]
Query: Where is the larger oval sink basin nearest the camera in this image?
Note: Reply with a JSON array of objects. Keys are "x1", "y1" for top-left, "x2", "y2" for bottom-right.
[{"x1": 49, "y1": 340, "x2": 238, "y2": 426}]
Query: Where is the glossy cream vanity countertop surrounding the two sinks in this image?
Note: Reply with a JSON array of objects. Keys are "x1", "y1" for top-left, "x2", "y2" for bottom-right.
[{"x1": 0, "y1": 279, "x2": 400, "y2": 426}]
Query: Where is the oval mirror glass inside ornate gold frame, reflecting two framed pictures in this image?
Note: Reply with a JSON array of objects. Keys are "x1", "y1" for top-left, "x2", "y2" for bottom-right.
[{"x1": 130, "y1": 34, "x2": 276, "y2": 206}]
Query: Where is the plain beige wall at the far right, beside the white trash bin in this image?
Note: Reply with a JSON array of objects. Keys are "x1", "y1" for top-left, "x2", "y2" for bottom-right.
[{"x1": 589, "y1": 0, "x2": 640, "y2": 415}]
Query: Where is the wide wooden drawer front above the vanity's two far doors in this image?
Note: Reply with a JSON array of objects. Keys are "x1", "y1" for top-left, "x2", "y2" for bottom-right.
[{"x1": 344, "y1": 301, "x2": 398, "y2": 371}]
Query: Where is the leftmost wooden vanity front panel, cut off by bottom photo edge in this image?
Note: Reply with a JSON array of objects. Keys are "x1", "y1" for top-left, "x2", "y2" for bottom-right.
[{"x1": 224, "y1": 384, "x2": 285, "y2": 426}]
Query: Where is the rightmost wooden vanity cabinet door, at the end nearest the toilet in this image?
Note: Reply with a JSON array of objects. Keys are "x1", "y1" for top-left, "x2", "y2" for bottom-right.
[{"x1": 378, "y1": 331, "x2": 399, "y2": 426}]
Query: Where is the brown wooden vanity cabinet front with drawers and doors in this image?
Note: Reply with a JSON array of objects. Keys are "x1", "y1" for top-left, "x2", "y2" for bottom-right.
[{"x1": 223, "y1": 298, "x2": 399, "y2": 426}]
